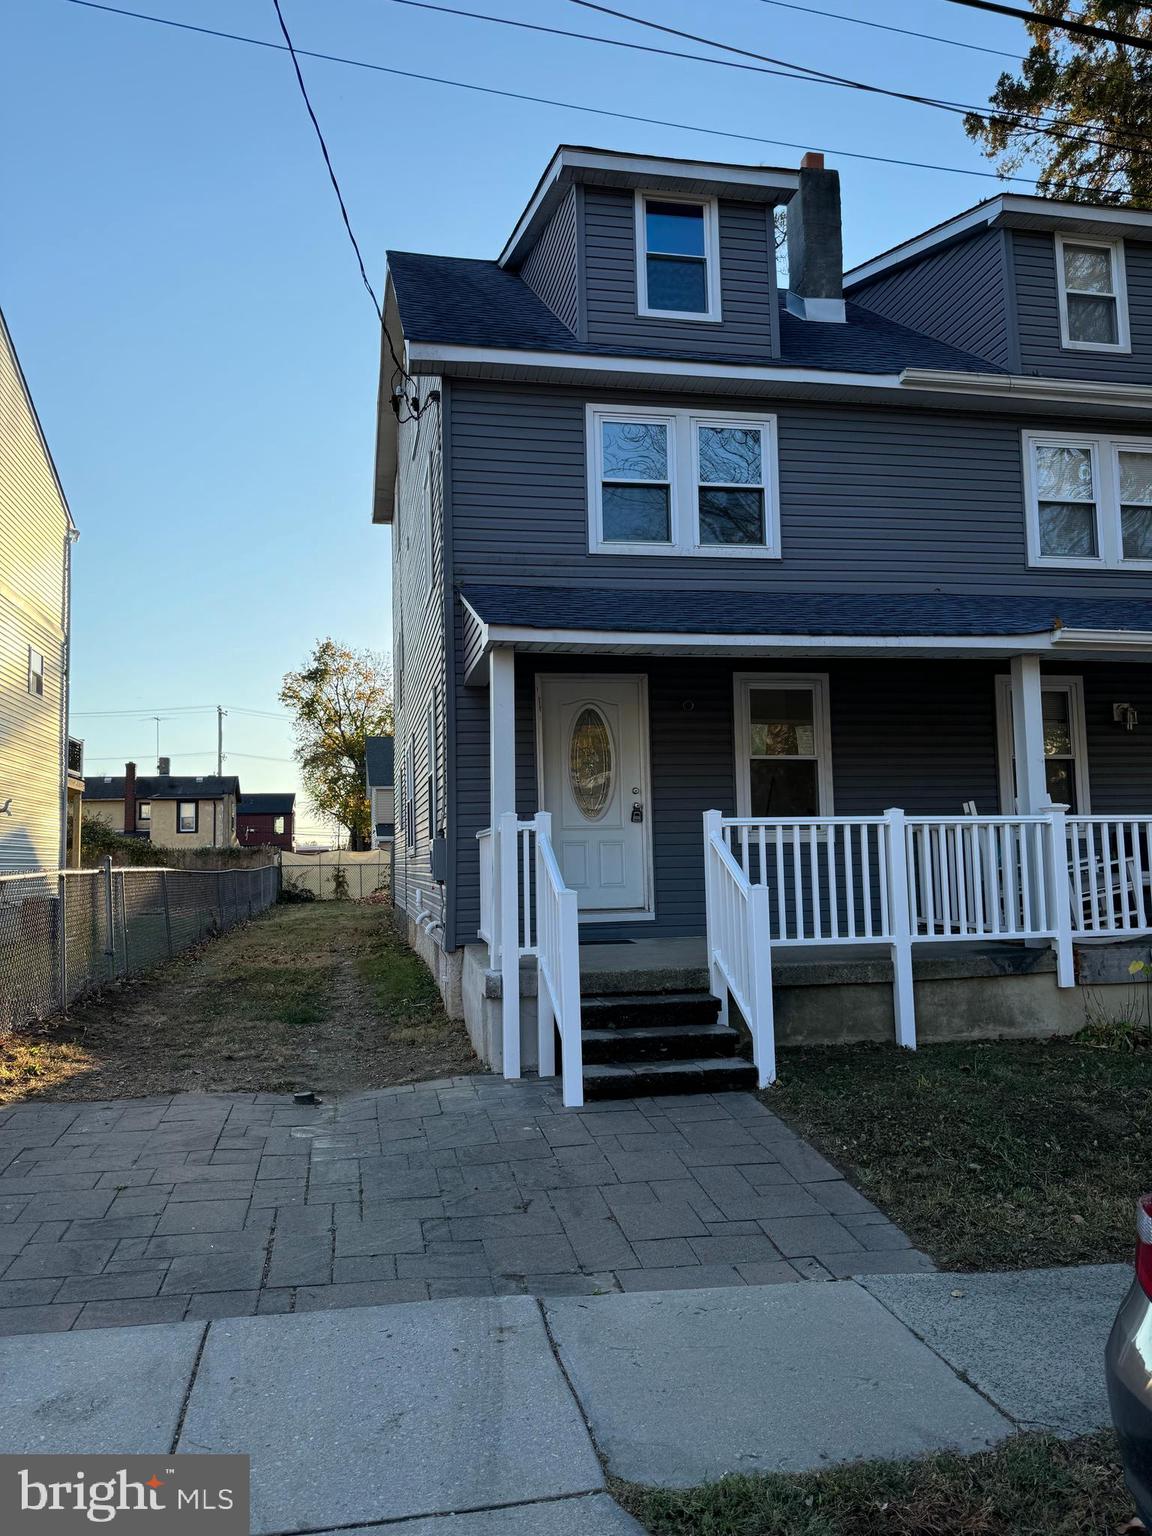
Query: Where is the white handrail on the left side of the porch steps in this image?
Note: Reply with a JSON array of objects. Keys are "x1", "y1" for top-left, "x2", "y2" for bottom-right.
[{"x1": 535, "y1": 811, "x2": 584, "y2": 1109}]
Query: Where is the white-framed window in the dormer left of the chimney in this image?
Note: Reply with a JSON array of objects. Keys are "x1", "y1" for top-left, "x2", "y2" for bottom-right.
[{"x1": 636, "y1": 192, "x2": 720, "y2": 319}]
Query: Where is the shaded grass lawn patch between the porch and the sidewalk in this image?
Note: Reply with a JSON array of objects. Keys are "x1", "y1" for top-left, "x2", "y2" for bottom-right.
[{"x1": 763, "y1": 1040, "x2": 1152, "y2": 1269}]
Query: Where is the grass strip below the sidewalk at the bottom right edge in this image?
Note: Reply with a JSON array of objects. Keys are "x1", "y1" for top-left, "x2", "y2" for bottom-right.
[{"x1": 613, "y1": 1433, "x2": 1132, "y2": 1536}]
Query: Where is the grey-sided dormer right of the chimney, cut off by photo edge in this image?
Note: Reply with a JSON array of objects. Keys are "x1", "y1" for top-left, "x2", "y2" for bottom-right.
[{"x1": 845, "y1": 194, "x2": 1152, "y2": 384}]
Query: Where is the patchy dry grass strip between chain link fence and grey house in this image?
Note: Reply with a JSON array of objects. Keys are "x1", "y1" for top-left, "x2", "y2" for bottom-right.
[{"x1": 0, "y1": 902, "x2": 479, "y2": 1103}]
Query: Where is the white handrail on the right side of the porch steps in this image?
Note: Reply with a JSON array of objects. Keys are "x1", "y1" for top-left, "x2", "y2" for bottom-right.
[{"x1": 703, "y1": 811, "x2": 776, "y2": 1087}]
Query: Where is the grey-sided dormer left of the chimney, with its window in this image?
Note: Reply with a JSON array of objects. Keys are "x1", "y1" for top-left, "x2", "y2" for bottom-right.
[{"x1": 499, "y1": 146, "x2": 804, "y2": 358}]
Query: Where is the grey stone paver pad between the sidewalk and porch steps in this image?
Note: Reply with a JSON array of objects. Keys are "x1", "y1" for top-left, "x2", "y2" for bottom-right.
[{"x1": 0, "y1": 1075, "x2": 932, "y2": 1333}]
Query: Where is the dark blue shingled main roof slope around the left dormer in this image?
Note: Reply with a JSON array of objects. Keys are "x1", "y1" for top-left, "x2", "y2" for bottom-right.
[{"x1": 389, "y1": 250, "x2": 1006, "y2": 373}]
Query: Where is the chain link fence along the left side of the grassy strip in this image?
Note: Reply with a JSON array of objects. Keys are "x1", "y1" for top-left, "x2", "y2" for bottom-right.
[{"x1": 0, "y1": 865, "x2": 280, "y2": 1034}]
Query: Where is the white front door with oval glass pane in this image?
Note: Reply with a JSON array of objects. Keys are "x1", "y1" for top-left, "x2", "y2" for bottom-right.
[{"x1": 538, "y1": 676, "x2": 650, "y2": 915}]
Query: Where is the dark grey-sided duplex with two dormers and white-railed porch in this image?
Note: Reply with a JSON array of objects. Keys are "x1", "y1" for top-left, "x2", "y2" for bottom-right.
[{"x1": 373, "y1": 147, "x2": 1152, "y2": 1101}]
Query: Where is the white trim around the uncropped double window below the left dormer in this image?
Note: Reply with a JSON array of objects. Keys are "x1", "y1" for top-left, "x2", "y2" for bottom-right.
[{"x1": 584, "y1": 404, "x2": 780, "y2": 559}]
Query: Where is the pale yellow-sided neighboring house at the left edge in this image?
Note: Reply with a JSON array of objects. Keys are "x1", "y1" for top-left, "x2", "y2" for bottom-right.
[{"x1": 0, "y1": 315, "x2": 83, "y2": 874}]
